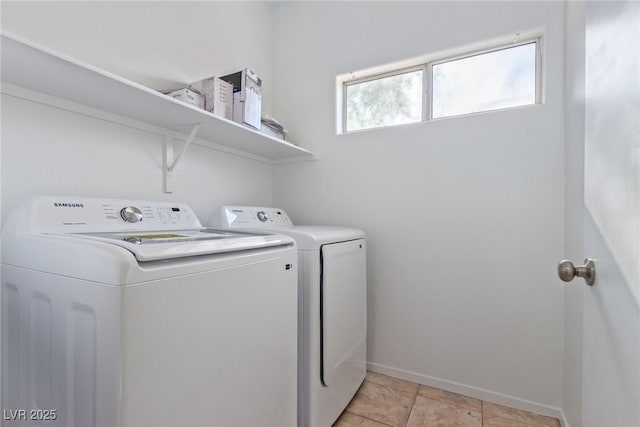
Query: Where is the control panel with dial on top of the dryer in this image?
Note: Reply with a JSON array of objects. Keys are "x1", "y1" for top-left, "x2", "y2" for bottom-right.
[{"x1": 216, "y1": 206, "x2": 293, "y2": 228}]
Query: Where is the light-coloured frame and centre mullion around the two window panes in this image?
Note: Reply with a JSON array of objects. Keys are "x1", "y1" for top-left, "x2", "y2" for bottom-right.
[{"x1": 339, "y1": 33, "x2": 544, "y2": 134}]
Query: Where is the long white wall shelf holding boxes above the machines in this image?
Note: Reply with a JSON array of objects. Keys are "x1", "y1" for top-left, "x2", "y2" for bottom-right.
[{"x1": 1, "y1": 34, "x2": 315, "y2": 161}]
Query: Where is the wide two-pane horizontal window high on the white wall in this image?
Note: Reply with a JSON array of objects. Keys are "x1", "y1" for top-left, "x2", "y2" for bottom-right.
[{"x1": 342, "y1": 39, "x2": 540, "y2": 132}]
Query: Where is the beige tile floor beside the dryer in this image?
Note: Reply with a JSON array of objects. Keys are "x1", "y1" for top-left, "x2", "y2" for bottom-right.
[{"x1": 333, "y1": 372, "x2": 560, "y2": 427}]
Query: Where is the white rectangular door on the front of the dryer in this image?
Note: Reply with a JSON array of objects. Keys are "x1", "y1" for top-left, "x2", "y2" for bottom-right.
[{"x1": 320, "y1": 239, "x2": 367, "y2": 386}]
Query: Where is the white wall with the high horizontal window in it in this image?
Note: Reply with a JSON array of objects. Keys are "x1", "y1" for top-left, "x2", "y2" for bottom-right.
[{"x1": 272, "y1": 2, "x2": 564, "y2": 415}]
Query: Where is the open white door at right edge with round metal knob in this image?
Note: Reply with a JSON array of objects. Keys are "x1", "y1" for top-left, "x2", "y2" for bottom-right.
[{"x1": 584, "y1": 1, "x2": 640, "y2": 427}]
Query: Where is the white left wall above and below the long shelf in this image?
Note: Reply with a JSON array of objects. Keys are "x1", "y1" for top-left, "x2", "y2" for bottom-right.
[{"x1": 1, "y1": 1, "x2": 272, "y2": 224}]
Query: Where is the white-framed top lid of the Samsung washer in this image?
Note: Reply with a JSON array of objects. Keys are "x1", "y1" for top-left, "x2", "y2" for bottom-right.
[{"x1": 65, "y1": 228, "x2": 293, "y2": 261}]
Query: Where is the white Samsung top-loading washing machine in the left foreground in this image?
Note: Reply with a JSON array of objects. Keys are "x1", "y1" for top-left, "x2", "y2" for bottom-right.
[{"x1": 2, "y1": 197, "x2": 298, "y2": 427}]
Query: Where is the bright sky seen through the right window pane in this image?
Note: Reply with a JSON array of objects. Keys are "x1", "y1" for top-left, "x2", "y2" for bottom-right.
[{"x1": 432, "y1": 43, "x2": 536, "y2": 118}]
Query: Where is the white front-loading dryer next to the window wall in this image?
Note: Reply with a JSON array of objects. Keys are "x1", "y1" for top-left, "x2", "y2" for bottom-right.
[{"x1": 211, "y1": 206, "x2": 367, "y2": 427}]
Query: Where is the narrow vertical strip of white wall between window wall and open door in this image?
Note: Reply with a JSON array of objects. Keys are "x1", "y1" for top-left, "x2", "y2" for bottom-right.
[{"x1": 562, "y1": 1, "x2": 586, "y2": 427}]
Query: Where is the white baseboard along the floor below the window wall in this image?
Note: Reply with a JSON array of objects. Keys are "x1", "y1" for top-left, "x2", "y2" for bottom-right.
[{"x1": 367, "y1": 362, "x2": 570, "y2": 427}]
